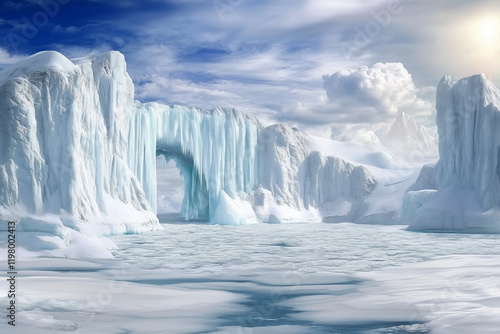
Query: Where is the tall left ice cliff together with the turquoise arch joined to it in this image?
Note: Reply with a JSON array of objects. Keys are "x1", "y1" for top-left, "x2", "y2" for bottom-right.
[{"x1": 0, "y1": 52, "x2": 262, "y2": 233}]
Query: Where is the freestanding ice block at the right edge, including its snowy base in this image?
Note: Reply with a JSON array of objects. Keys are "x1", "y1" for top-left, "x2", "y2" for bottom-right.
[{"x1": 410, "y1": 75, "x2": 500, "y2": 232}]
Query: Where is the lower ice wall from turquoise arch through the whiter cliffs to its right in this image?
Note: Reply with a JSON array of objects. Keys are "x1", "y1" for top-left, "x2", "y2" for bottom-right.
[{"x1": 129, "y1": 108, "x2": 375, "y2": 224}]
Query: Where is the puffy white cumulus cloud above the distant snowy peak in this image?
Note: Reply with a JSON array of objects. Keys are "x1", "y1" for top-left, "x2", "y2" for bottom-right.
[{"x1": 323, "y1": 63, "x2": 433, "y2": 122}]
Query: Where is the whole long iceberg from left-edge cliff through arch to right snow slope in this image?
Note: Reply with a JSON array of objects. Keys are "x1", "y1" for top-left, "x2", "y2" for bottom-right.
[{"x1": 0, "y1": 51, "x2": 426, "y2": 254}]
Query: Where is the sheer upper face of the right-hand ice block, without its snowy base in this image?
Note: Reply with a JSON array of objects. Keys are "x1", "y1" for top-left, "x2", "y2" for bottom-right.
[{"x1": 437, "y1": 75, "x2": 500, "y2": 210}]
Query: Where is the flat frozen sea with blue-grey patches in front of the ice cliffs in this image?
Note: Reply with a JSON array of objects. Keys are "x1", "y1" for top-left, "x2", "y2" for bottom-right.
[{"x1": 0, "y1": 215, "x2": 500, "y2": 334}]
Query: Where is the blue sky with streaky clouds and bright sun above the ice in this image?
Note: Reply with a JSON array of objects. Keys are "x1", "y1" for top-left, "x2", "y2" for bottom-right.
[{"x1": 0, "y1": 0, "x2": 500, "y2": 138}]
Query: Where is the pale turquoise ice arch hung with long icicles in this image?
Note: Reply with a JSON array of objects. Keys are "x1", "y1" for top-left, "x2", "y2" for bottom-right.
[{"x1": 128, "y1": 102, "x2": 262, "y2": 221}]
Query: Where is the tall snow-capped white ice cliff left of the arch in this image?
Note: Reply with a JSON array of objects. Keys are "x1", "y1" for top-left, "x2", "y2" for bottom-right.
[{"x1": 0, "y1": 52, "x2": 160, "y2": 254}]
